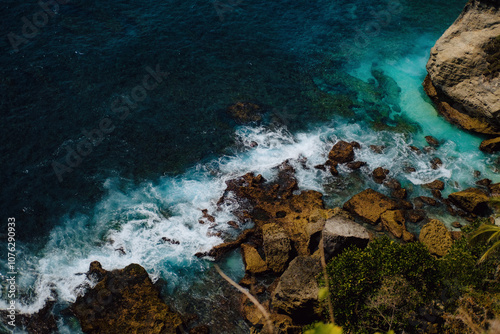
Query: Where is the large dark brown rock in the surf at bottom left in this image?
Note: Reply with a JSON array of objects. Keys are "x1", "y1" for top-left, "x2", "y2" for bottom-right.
[{"x1": 70, "y1": 261, "x2": 182, "y2": 334}]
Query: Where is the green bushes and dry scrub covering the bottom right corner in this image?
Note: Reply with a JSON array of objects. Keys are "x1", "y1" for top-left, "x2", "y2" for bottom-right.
[{"x1": 320, "y1": 221, "x2": 500, "y2": 333}]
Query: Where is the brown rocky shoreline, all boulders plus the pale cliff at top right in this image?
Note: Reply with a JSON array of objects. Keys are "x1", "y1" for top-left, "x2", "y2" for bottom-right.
[{"x1": 0, "y1": 0, "x2": 500, "y2": 334}]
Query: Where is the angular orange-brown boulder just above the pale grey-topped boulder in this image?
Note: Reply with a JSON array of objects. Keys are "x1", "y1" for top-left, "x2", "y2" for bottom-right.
[{"x1": 344, "y1": 189, "x2": 398, "y2": 225}]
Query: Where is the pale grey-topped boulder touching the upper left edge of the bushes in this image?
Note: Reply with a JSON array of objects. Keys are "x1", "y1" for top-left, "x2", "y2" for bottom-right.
[{"x1": 322, "y1": 215, "x2": 370, "y2": 261}]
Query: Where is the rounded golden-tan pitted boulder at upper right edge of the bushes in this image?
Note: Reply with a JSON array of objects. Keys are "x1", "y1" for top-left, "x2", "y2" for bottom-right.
[{"x1": 418, "y1": 219, "x2": 453, "y2": 256}]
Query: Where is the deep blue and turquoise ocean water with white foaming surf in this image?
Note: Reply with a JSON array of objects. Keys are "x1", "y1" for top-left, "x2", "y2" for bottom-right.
[{"x1": 0, "y1": 0, "x2": 500, "y2": 333}]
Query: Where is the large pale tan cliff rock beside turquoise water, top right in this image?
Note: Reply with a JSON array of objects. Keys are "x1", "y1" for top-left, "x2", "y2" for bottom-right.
[{"x1": 424, "y1": 0, "x2": 500, "y2": 135}]
